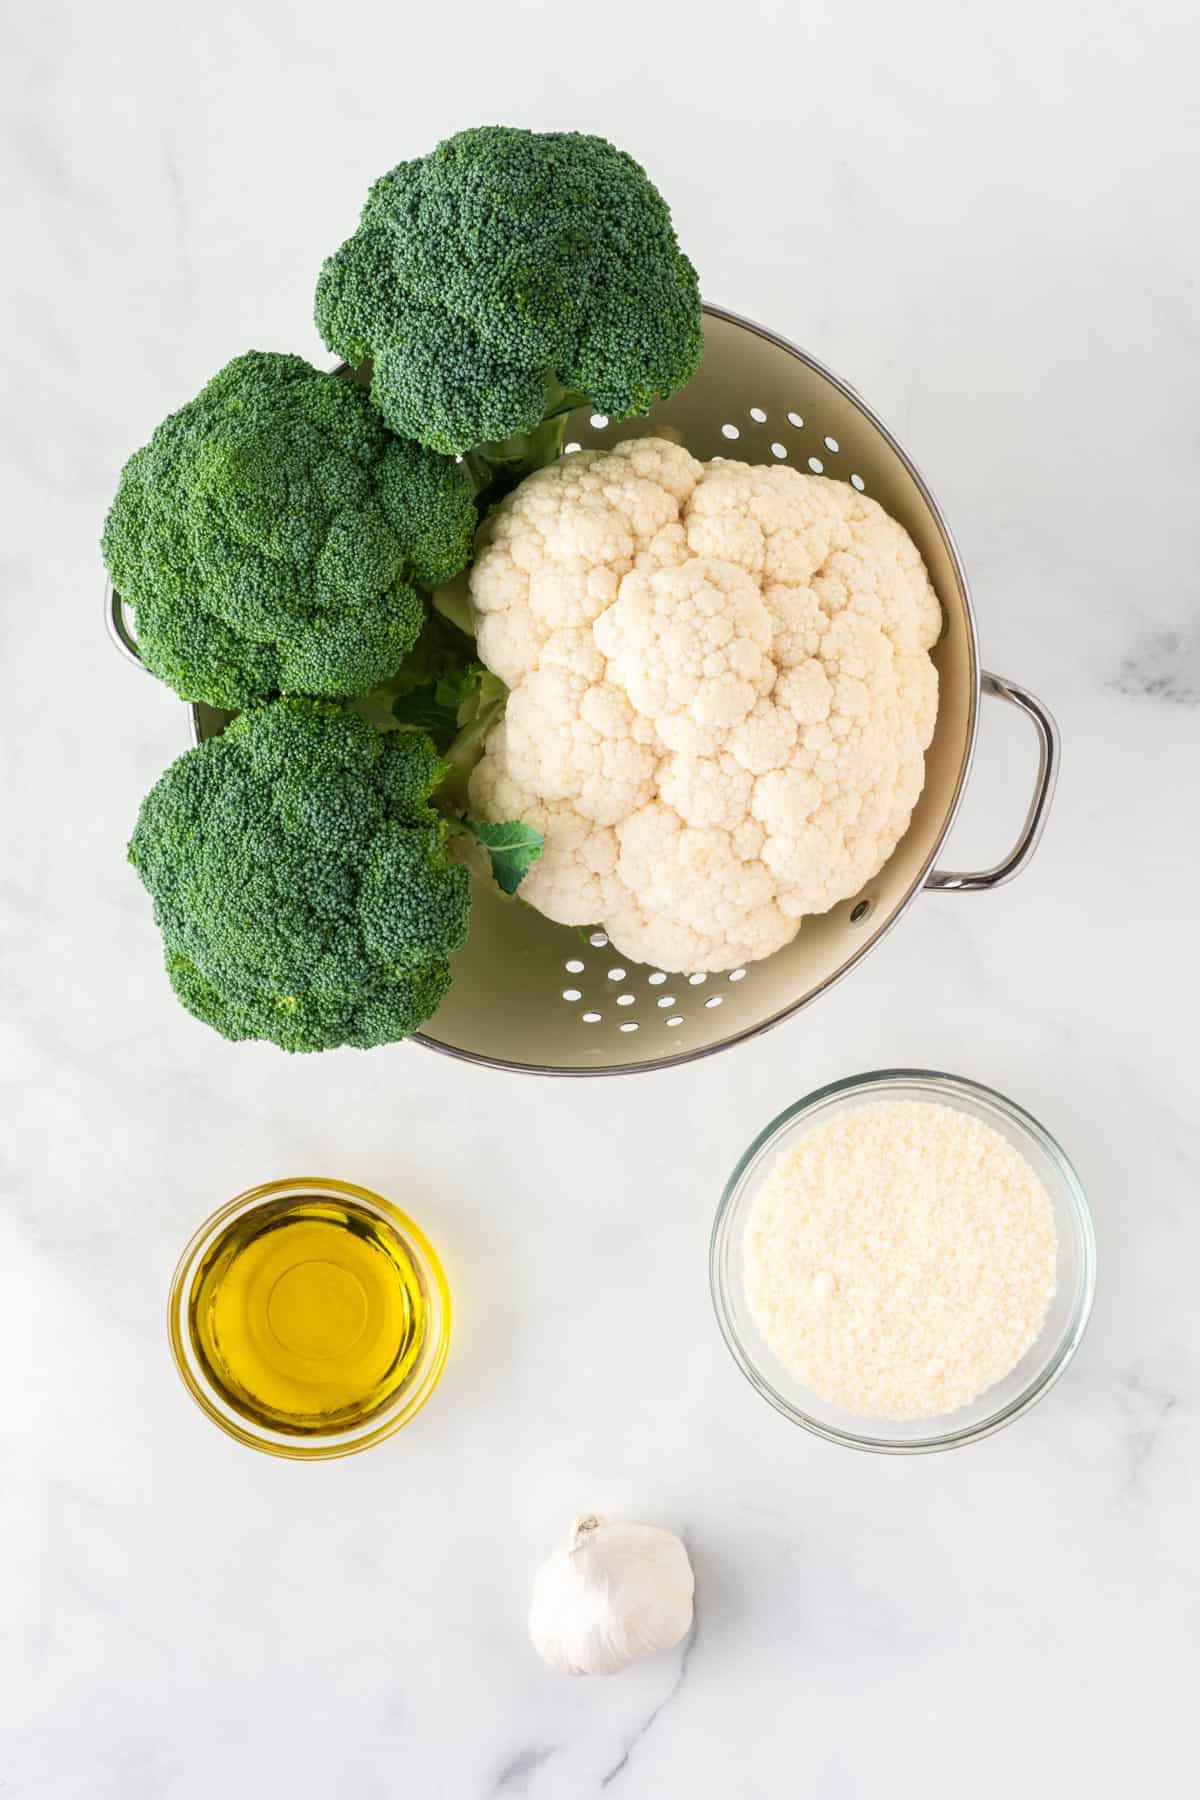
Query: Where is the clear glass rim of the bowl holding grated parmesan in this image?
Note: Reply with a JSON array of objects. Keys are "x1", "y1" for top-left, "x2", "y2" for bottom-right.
[{"x1": 709, "y1": 1069, "x2": 1096, "y2": 1456}]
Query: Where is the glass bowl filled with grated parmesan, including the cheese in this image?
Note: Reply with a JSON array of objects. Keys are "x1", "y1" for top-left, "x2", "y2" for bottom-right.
[{"x1": 711, "y1": 1069, "x2": 1096, "y2": 1454}]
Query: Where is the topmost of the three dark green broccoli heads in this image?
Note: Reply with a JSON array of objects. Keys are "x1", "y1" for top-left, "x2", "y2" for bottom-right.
[{"x1": 317, "y1": 126, "x2": 702, "y2": 454}]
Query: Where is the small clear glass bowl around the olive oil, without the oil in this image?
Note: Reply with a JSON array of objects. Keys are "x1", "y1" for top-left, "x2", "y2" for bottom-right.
[{"x1": 167, "y1": 1175, "x2": 450, "y2": 1462}]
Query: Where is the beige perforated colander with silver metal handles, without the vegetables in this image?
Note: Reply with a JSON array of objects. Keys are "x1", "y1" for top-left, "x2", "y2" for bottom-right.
[{"x1": 104, "y1": 306, "x2": 1060, "y2": 1075}]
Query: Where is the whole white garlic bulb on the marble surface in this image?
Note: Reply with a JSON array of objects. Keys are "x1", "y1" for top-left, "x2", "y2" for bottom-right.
[{"x1": 529, "y1": 1512, "x2": 696, "y2": 1676}]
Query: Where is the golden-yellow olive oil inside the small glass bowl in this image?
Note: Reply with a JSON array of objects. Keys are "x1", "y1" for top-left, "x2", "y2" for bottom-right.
[{"x1": 187, "y1": 1192, "x2": 430, "y2": 1438}]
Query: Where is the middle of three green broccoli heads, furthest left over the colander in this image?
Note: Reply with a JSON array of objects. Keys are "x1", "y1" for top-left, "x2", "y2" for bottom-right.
[{"x1": 103, "y1": 351, "x2": 477, "y2": 709}]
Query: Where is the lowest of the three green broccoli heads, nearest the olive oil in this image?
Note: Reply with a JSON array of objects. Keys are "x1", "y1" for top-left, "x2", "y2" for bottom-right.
[{"x1": 130, "y1": 700, "x2": 471, "y2": 1051}]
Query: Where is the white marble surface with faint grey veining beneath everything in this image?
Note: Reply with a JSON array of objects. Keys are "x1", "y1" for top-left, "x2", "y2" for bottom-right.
[{"x1": 0, "y1": 0, "x2": 1200, "y2": 1800}]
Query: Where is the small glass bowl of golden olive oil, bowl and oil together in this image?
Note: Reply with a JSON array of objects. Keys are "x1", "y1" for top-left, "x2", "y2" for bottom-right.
[{"x1": 169, "y1": 1177, "x2": 450, "y2": 1458}]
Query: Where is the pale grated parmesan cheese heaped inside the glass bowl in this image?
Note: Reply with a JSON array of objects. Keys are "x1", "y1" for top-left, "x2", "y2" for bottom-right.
[{"x1": 741, "y1": 1100, "x2": 1058, "y2": 1418}]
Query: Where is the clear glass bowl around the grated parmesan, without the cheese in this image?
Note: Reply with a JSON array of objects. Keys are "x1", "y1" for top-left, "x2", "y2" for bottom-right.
[{"x1": 709, "y1": 1069, "x2": 1096, "y2": 1456}]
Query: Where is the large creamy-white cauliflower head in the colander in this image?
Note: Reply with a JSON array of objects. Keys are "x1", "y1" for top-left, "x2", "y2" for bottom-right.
[{"x1": 470, "y1": 437, "x2": 941, "y2": 972}]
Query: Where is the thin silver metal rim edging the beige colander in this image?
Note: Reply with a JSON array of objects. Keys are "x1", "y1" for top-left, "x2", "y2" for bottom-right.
[{"x1": 104, "y1": 302, "x2": 981, "y2": 1076}]
